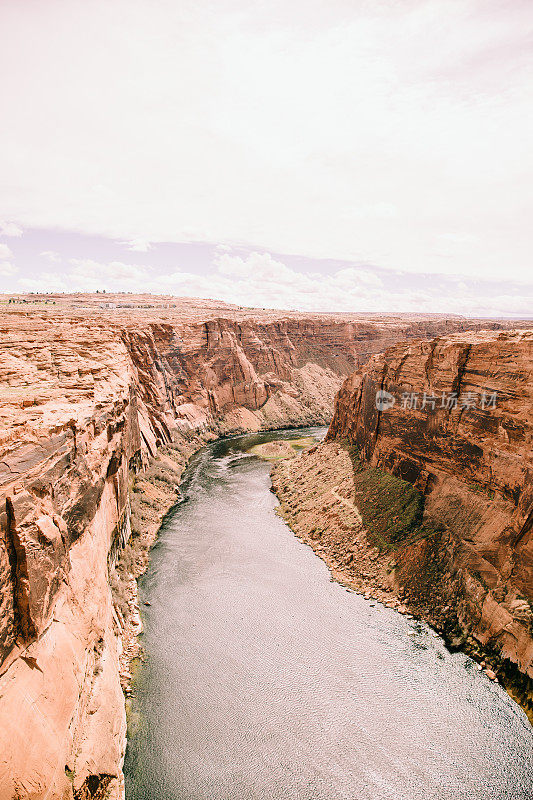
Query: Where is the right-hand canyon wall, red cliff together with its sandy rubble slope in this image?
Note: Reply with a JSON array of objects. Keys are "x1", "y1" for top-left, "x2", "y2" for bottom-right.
[{"x1": 273, "y1": 330, "x2": 533, "y2": 719}]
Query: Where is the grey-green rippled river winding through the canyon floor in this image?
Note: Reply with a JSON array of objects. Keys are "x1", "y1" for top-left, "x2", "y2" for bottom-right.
[{"x1": 125, "y1": 429, "x2": 533, "y2": 800}]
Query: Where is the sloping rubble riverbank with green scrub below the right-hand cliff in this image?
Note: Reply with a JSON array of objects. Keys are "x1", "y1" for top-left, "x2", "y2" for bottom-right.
[{"x1": 271, "y1": 441, "x2": 533, "y2": 723}]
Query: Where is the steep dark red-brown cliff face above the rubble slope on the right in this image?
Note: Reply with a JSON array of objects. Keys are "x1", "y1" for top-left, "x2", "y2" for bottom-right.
[{"x1": 327, "y1": 330, "x2": 533, "y2": 714}]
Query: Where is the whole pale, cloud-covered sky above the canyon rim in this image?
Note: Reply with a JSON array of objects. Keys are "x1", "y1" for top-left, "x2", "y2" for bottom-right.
[{"x1": 0, "y1": 0, "x2": 533, "y2": 317}]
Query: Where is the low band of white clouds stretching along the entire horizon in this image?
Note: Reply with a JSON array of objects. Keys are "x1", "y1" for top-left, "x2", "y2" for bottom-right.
[{"x1": 10, "y1": 242, "x2": 533, "y2": 317}]
